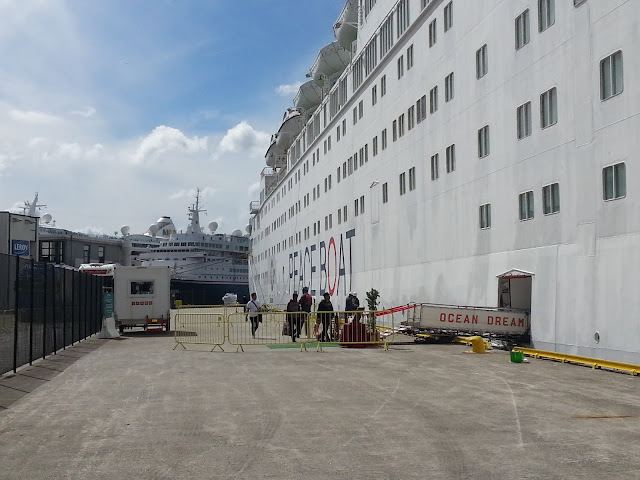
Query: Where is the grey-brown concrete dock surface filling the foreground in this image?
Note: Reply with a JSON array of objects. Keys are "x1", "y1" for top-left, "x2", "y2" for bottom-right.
[{"x1": 0, "y1": 332, "x2": 640, "y2": 480}]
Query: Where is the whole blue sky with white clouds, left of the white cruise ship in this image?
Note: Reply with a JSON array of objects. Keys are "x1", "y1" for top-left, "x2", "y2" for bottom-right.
[{"x1": 0, "y1": 0, "x2": 344, "y2": 235}]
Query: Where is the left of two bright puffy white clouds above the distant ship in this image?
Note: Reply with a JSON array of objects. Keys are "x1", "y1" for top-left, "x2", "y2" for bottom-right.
[{"x1": 132, "y1": 125, "x2": 207, "y2": 164}]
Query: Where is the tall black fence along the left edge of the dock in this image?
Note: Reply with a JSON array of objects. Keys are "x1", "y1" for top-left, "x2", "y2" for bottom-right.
[{"x1": 0, "y1": 254, "x2": 112, "y2": 374}]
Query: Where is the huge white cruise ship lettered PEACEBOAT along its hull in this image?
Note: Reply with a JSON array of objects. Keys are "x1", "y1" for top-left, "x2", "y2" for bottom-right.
[{"x1": 249, "y1": 0, "x2": 640, "y2": 363}]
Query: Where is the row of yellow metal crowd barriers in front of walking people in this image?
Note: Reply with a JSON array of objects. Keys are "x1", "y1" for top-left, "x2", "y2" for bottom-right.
[{"x1": 174, "y1": 306, "x2": 395, "y2": 351}]
